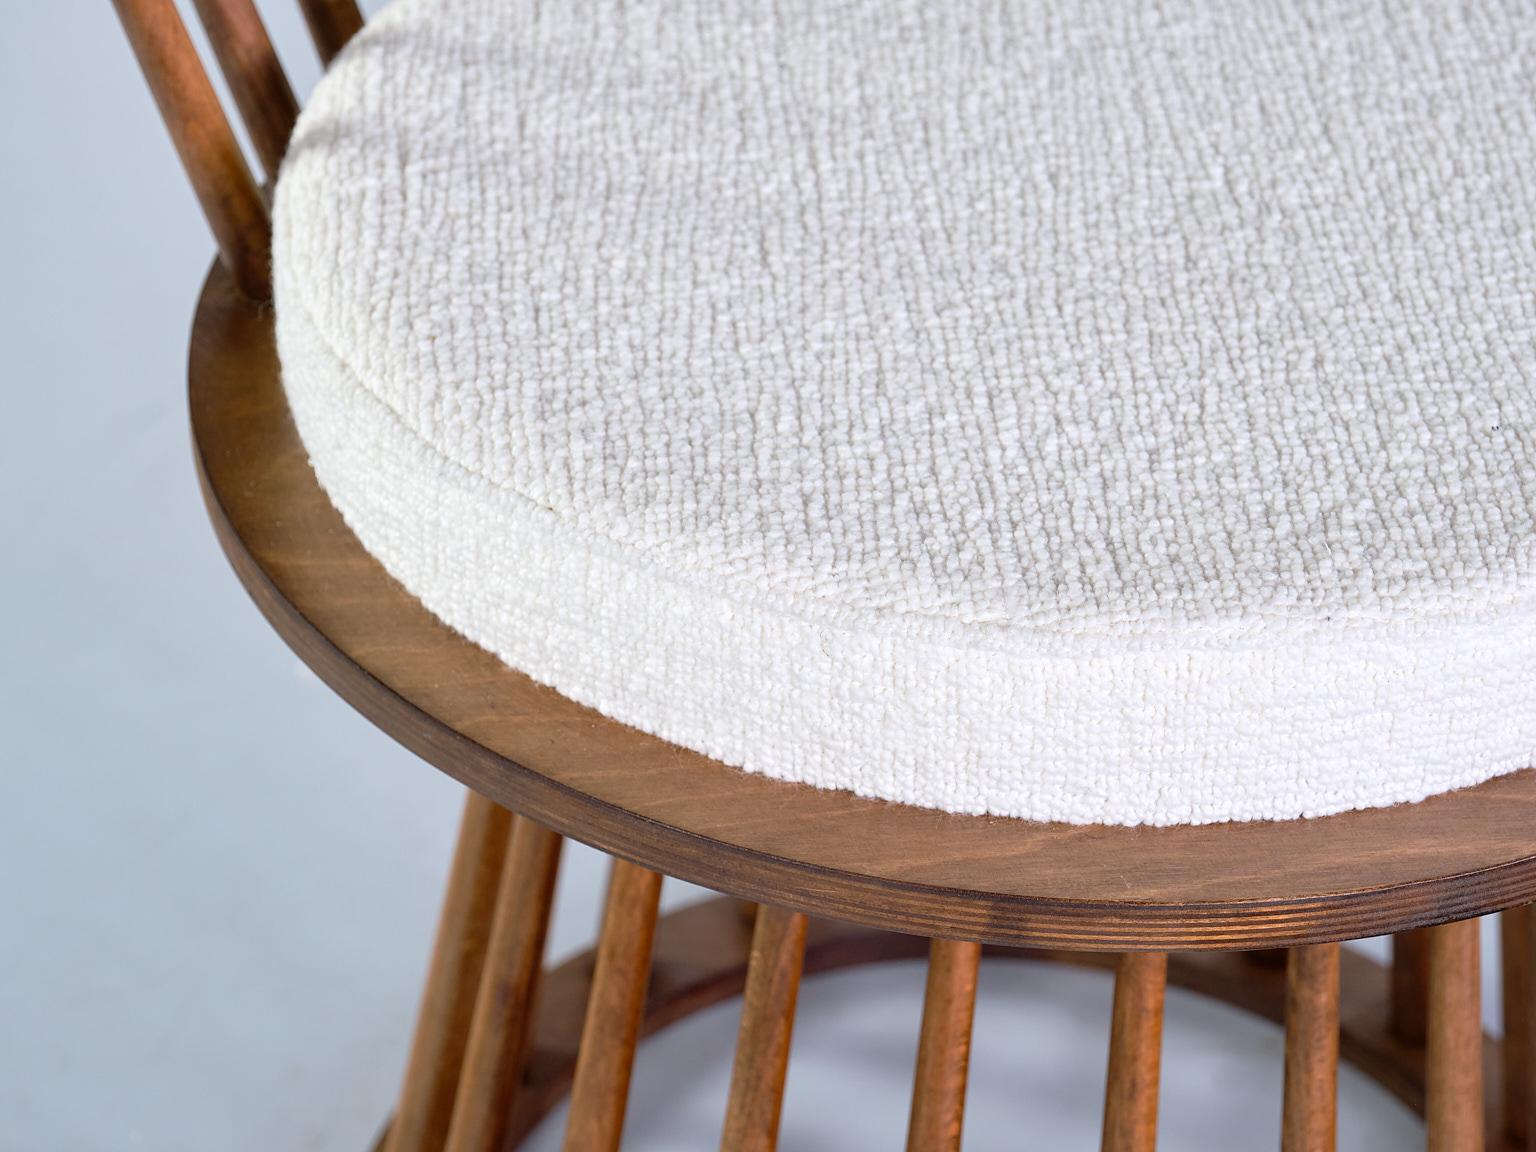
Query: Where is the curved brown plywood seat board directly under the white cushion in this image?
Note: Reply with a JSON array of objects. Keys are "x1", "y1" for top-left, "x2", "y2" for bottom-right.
[{"x1": 190, "y1": 269, "x2": 1536, "y2": 951}]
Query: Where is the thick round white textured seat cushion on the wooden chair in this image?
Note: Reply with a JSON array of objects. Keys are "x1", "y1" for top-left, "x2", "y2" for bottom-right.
[{"x1": 273, "y1": 0, "x2": 1536, "y2": 823}]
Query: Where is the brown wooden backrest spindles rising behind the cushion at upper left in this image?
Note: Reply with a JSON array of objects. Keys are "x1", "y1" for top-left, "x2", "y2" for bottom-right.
[{"x1": 112, "y1": 0, "x2": 362, "y2": 301}]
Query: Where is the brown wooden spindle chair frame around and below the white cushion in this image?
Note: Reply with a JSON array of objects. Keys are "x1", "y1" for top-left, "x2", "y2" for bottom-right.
[{"x1": 114, "y1": 0, "x2": 1536, "y2": 1152}]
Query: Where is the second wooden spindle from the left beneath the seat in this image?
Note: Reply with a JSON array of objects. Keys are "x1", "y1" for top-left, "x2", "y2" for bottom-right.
[{"x1": 447, "y1": 816, "x2": 562, "y2": 1152}]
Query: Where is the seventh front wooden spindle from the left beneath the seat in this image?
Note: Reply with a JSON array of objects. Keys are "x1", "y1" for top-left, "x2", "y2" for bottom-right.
[{"x1": 1279, "y1": 945, "x2": 1339, "y2": 1152}]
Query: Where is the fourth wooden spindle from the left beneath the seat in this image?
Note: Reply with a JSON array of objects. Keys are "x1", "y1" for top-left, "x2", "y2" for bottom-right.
[{"x1": 720, "y1": 905, "x2": 805, "y2": 1152}]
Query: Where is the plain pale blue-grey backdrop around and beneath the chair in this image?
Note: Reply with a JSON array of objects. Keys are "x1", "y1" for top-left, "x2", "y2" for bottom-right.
[{"x1": 0, "y1": 0, "x2": 1498, "y2": 1152}]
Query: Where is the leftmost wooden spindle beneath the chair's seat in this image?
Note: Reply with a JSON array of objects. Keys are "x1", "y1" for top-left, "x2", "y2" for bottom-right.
[{"x1": 384, "y1": 793, "x2": 511, "y2": 1152}]
